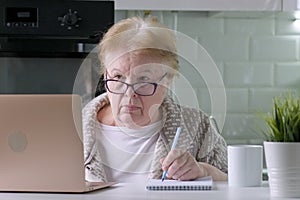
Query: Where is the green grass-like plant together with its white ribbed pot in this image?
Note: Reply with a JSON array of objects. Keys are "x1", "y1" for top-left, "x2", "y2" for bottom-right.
[{"x1": 262, "y1": 93, "x2": 300, "y2": 197}]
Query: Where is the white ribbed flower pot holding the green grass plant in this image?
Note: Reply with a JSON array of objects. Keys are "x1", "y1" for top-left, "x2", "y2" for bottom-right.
[{"x1": 264, "y1": 142, "x2": 300, "y2": 197}]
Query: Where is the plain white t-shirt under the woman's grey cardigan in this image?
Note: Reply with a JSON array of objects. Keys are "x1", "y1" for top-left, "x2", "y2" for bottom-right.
[{"x1": 96, "y1": 121, "x2": 162, "y2": 182}]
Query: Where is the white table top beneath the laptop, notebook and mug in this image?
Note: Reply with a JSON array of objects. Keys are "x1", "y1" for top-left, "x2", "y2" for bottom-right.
[{"x1": 0, "y1": 182, "x2": 298, "y2": 200}]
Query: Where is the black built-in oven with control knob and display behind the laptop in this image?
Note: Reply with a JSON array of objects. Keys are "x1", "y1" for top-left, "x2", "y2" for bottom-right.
[{"x1": 0, "y1": 0, "x2": 114, "y2": 102}]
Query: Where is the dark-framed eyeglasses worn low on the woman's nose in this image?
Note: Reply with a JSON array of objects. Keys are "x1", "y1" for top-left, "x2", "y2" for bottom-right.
[{"x1": 104, "y1": 73, "x2": 167, "y2": 96}]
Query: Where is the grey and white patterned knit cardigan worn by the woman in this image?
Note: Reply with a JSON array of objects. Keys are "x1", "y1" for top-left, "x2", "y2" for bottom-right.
[{"x1": 83, "y1": 93, "x2": 227, "y2": 182}]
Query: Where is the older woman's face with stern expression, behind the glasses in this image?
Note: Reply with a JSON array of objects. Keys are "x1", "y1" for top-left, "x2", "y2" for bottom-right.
[{"x1": 106, "y1": 54, "x2": 167, "y2": 128}]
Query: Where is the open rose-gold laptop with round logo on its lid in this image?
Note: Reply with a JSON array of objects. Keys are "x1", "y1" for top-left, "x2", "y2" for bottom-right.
[{"x1": 0, "y1": 94, "x2": 114, "y2": 193}]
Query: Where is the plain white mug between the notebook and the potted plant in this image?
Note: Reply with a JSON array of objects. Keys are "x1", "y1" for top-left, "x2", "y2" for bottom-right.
[{"x1": 227, "y1": 145, "x2": 263, "y2": 187}]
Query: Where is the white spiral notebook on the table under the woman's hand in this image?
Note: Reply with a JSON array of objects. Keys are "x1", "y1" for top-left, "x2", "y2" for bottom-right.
[{"x1": 146, "y1": 176, "x2": 213, "y2": 190}]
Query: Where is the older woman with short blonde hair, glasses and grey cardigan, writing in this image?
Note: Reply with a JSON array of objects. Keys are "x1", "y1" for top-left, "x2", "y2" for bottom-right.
[{"x1": 83, "y1": 17, "x2": 227, "y2": 182}]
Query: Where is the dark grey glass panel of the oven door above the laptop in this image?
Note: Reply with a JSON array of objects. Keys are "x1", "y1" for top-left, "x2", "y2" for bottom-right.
[{"x1": 0, "y1": 53, "x2": 100, "y2": 105}]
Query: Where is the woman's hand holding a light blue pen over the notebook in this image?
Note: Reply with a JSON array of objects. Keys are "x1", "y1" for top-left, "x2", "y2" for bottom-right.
[{"x1": 160, "y1": 149, "x2": 209, "y2": 181}]
